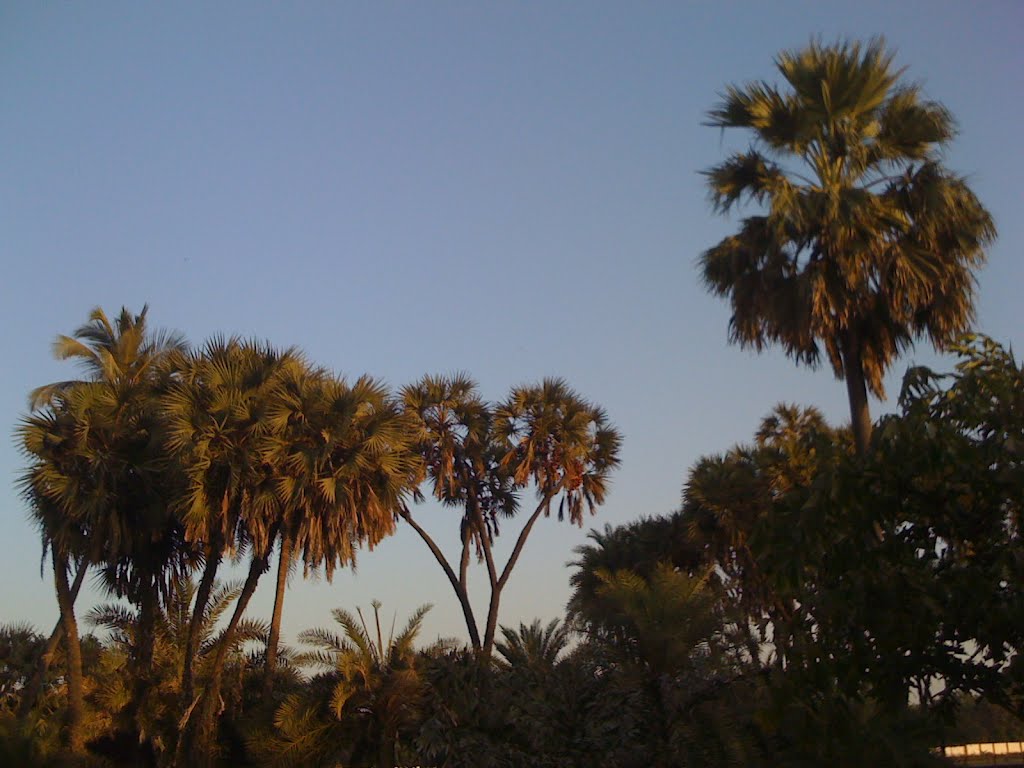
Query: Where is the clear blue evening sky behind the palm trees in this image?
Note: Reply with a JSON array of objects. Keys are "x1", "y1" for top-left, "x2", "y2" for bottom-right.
[{"x1": 0, "y1": 0, "x2": 1024, "y2": 637}]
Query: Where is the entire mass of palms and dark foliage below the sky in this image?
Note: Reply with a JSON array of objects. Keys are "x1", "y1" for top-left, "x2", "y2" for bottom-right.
[{"x1": 0, "y1": 41, "x2": 1024, "y2": 768}]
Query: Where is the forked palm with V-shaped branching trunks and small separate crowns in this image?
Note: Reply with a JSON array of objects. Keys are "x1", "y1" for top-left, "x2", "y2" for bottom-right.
[{"x1": 401, "y1": 376, "x2": 621, "y2": 657}]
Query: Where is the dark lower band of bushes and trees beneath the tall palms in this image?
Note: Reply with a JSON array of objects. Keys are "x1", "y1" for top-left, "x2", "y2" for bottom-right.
[{"x1": 8, "y1": 338, "x2": 1024, "y2": 766}]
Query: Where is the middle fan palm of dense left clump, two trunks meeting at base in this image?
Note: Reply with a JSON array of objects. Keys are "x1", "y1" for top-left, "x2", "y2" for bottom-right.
[{"x1": 162, "y1": 339, "x2": 308, "y2": 765}]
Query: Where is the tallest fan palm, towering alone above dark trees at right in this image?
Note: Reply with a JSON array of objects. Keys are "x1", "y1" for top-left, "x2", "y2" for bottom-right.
[{"x1": 701, "y1": 40, "x2": 995, "y2": 453}]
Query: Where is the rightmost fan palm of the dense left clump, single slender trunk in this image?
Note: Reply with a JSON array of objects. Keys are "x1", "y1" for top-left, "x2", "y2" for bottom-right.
[{"x1": 260, "y1": 369, "x2": 414, "y2": 697}]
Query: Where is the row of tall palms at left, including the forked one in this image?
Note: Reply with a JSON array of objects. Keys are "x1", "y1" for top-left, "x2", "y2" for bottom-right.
[{"x1": 19, "y1": 309, "x2": 618, "y2": 764}]
